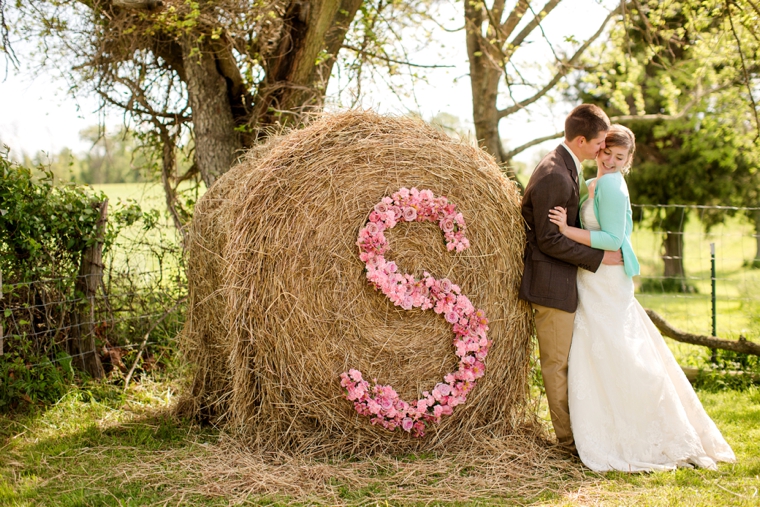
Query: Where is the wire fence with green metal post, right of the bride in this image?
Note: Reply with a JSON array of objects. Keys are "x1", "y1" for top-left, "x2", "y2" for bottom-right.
[{"x1": 632, "y1": 205, "x2": 760, "y2": 352}]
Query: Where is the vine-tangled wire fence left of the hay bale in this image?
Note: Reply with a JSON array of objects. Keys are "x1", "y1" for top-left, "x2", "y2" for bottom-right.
[{"x1": 0, "y1": 270, "x2": 186, "y2": 373}]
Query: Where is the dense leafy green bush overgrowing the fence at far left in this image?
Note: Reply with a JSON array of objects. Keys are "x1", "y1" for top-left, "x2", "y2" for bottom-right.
[{"x1": 0, "y1": 153, "x2": 182, "y2": 411}]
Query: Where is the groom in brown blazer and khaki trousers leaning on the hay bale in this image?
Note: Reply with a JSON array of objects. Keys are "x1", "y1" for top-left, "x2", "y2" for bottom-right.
[{"x1": 519, "y1": 104, "x2": 622, "y2": 455}]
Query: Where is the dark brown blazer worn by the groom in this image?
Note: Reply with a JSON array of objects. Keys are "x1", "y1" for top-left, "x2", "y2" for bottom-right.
[{"x1": 519, "y1": 145, "x2": 604, "y2": 313}]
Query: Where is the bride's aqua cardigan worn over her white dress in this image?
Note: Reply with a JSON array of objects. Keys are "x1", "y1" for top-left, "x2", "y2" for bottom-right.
[{"x1": 591, "y1": 175, "x2": 628, "y2": 250}]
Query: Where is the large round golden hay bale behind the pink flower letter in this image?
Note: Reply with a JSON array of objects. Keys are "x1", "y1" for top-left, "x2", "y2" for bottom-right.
[{"x1": 183, "y1": 112, "x2": 530, "y2": 452}]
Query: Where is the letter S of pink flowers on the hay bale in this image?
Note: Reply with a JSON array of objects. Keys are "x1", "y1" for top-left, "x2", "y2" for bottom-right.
[{"x1": 340, "y1": 188, "x2": 491, "y2": 437}]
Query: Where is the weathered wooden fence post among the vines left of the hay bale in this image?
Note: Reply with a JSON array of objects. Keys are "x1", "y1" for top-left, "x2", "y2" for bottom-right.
[{"x1": 69, "y1": 199, "x2": 108, "y2": 379}]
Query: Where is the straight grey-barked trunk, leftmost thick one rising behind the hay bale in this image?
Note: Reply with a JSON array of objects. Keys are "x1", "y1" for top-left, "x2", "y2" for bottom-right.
[{"x1": 182, "y1": 36, "x2": 241, "y2": 188}]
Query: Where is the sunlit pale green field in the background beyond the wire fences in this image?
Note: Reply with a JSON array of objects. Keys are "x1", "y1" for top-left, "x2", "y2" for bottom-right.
[{"x1": 94, "y1": 183, "x2": 760, "y2": 365}]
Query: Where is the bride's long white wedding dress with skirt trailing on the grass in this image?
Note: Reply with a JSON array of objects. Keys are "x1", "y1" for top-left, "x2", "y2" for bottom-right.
[{"x1": 568, "y1": 199, "x2": 735, "y2": 472}]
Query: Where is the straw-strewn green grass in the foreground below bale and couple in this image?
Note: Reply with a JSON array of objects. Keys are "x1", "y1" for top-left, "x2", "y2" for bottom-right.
[{"x1": 0, "y1": 380, "x2": 760, "y2": 507}]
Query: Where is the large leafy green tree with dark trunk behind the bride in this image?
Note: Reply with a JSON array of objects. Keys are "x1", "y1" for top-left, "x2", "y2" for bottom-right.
[{"x1": 569, "y1": 0, "x2": 760, "y2": 291}]
